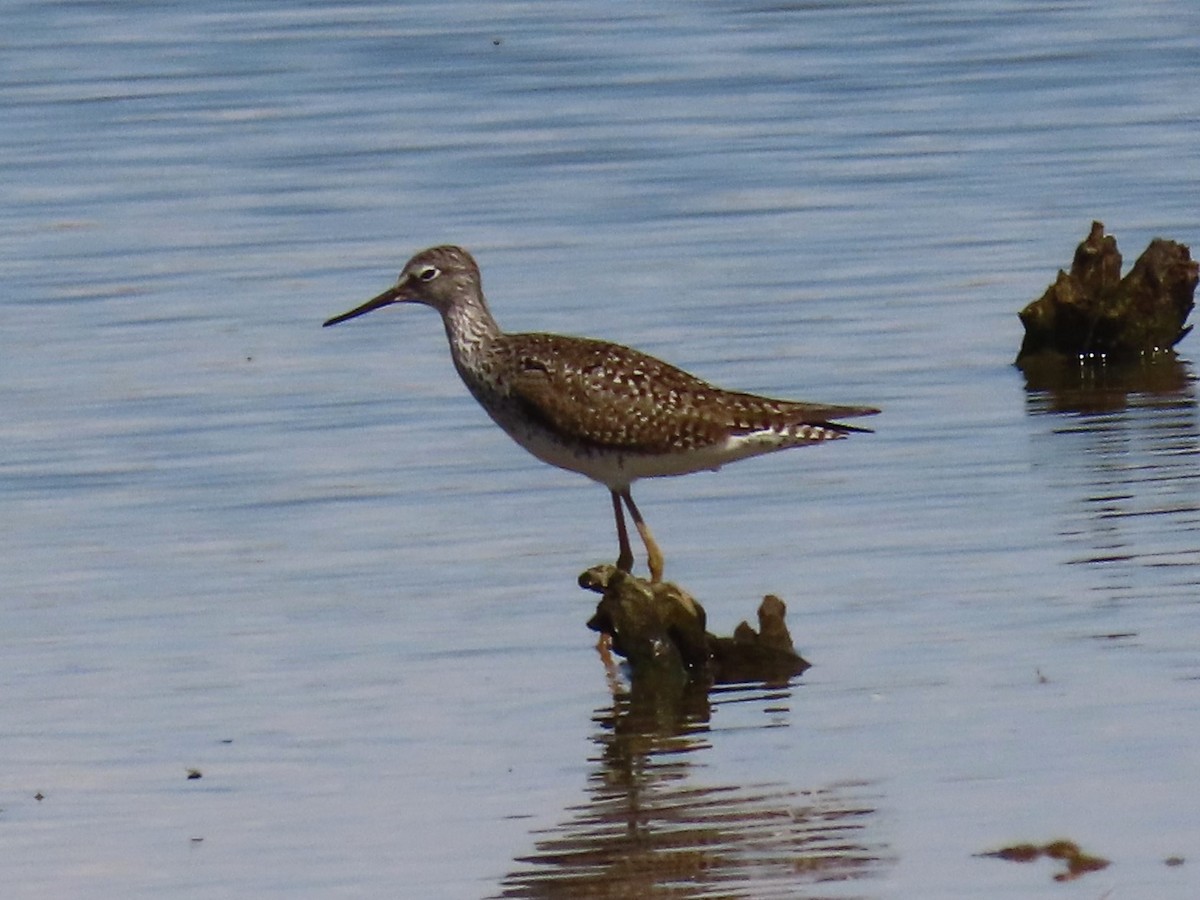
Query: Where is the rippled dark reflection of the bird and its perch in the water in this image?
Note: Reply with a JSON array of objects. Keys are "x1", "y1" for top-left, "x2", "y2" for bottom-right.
[{"x1": 499, "y1": 679, "x2": 888, "y2": 898}]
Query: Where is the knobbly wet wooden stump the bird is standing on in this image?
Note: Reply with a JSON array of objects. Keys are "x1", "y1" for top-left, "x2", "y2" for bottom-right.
[{"x1": 580, "y1": 565, "x2": 809, "y2": 684}]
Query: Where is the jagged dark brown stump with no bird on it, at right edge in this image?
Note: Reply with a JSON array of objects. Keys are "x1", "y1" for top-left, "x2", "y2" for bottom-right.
[{"x1": 1016, "y1": 222, "x2": 1198, "y2": 368}]
